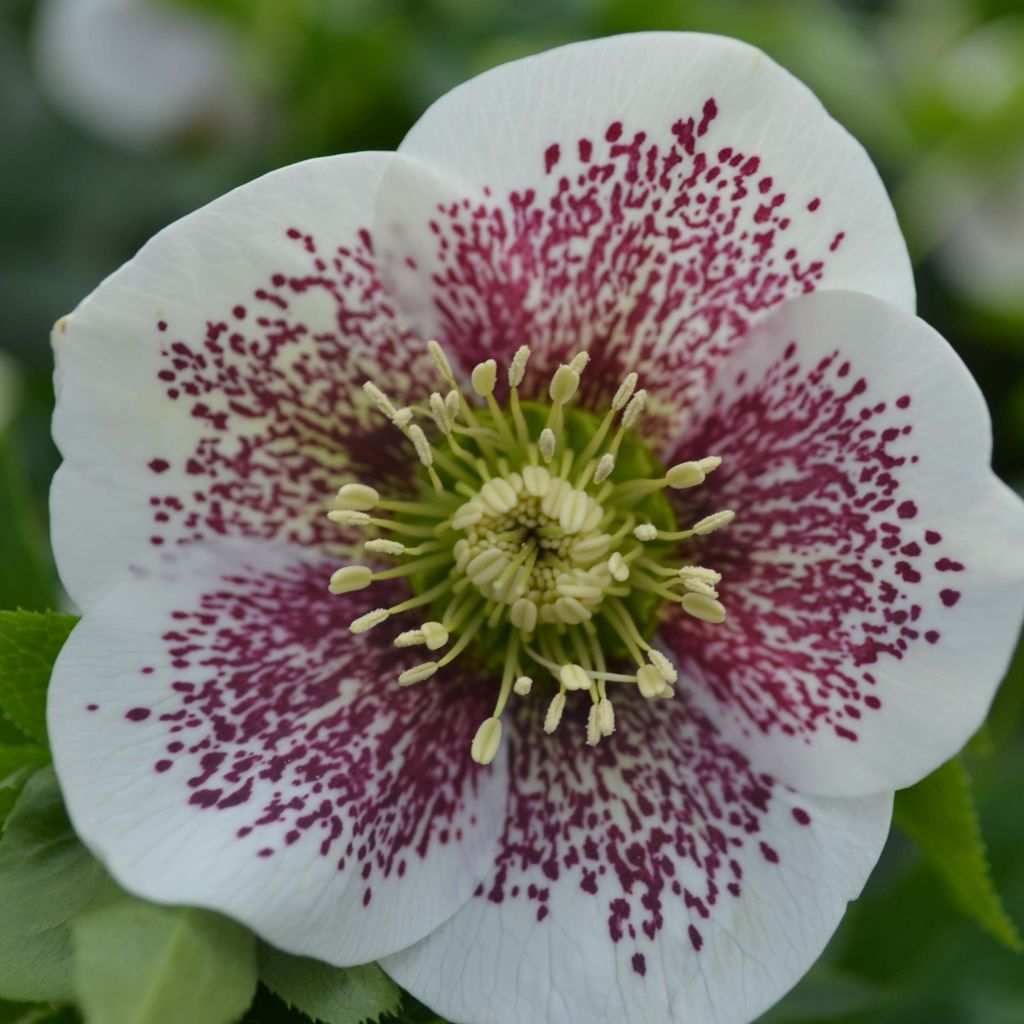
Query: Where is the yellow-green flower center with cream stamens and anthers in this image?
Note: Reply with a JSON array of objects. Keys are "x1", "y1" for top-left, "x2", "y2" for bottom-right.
[{"x1": 329, "y1": 341, "x2": 733, "y2": 764}]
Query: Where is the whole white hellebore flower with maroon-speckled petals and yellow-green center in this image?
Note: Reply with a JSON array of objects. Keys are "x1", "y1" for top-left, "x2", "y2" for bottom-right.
[{"x1": 49, "y1": 34, "x2": 1024, "y2": 1024}]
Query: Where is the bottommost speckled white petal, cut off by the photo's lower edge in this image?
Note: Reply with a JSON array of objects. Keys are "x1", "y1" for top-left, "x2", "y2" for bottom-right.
[{"x1": 382, "y1": 695, "x2": 892, "y2": 1024}]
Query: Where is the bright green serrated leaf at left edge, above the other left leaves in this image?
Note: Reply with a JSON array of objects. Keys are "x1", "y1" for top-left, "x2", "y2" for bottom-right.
[{"x1": 0, "y1": 611, "x2": 78, "y2": 743}]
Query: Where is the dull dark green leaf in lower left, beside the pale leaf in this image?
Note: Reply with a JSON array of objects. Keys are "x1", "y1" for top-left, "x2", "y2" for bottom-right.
[{"x1": 0, "y1": 767, "x2": 117, "y2": 1000}]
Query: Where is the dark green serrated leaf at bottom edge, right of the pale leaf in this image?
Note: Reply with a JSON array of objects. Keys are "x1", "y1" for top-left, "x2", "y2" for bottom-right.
[{"x1": 259, "y1": 944, "x2": 401, "y2": 1024}]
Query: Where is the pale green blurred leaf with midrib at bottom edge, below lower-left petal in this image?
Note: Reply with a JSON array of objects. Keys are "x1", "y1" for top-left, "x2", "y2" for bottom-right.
[{"x1": 74, "y1": 896, "x2": 257, "y2": 1024}]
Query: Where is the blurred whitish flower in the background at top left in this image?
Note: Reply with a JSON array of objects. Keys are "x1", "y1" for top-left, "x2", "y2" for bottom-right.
[{"x1": 35, "y1": 0, "x2": 257, "y2": 148}]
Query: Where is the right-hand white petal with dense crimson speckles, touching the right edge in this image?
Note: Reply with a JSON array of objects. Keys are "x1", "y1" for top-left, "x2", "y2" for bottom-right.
[{"x1": 665, "y1": 292, "x2": 1024, "y2": 795}]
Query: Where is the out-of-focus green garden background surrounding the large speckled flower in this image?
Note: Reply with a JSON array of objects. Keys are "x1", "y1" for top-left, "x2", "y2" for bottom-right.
[{"x1": 0, "y1": 0, "x2": 1024, "y2": 1024}]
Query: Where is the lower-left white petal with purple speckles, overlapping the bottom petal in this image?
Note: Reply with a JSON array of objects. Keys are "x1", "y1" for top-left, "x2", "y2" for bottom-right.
[{"x1": 49, "y1": 542, "x2": 507, "y2": 964}]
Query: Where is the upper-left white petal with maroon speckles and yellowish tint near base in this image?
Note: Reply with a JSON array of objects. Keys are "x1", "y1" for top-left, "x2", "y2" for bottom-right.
[{"x1": 51, "y1": 154, "x2": 425, "y2": 607}]
